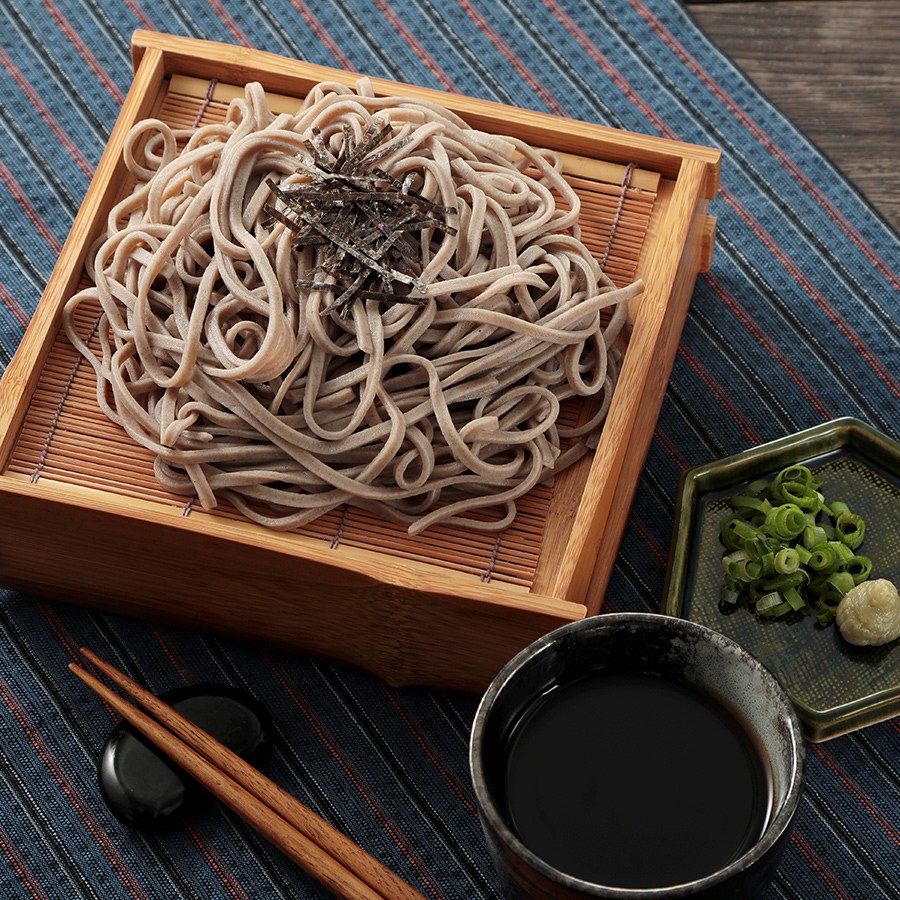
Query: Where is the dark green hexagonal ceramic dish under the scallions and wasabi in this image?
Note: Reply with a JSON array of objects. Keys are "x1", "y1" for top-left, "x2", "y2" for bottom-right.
[{"x1": 662, "y1": 418, "x2": 900, "y2": 741}]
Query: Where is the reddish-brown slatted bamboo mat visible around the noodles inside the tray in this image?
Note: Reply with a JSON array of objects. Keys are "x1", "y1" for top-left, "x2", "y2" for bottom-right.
[{"x1": 8, "y1": 78, "x2": 658, "y2": 589}]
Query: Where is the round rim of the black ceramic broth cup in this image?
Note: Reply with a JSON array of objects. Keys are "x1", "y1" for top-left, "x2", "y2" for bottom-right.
[{"x1": 469, "y1": 612, "x2": 806, "y2": 900}]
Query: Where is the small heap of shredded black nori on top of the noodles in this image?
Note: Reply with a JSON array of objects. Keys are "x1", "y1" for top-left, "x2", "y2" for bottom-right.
[{"x1": 266, "y1": 118, "x2": 456, "y2": 316}]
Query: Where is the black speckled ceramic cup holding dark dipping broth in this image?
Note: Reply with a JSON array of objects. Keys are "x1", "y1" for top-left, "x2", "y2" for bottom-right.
[{"x1": 470, "y1": 613, "x2": 806, "y2": 900}]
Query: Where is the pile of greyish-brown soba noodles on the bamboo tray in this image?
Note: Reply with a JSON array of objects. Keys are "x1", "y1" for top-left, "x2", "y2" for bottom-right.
[{"x1": 64, "y1": 80, "x2": 640, "y2": 533}]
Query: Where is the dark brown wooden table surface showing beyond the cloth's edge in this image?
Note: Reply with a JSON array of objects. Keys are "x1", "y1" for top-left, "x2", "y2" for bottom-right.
[{"x1": 686, "y1": 0, "x2": 900, "y2": 231}]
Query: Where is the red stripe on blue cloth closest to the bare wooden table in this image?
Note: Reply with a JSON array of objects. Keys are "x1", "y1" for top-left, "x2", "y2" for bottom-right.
[{"x1": 631, "y1": 0, "x2": 900, "y2": 287}]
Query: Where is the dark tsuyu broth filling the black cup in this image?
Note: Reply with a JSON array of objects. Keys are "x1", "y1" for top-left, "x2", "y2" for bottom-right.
[{"x1": 503, "y1": 671, "x2": 771, "y2": 888}]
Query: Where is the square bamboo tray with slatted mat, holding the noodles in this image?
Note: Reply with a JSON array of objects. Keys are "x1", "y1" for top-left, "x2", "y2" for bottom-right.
[{"x1": 0, "y1": 32, "x2": 719, "y2": 690}]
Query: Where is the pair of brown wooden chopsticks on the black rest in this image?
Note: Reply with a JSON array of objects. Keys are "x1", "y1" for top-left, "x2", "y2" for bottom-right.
[{"x1": 69, "y1": 647, "x2": 422, "y2": 900}]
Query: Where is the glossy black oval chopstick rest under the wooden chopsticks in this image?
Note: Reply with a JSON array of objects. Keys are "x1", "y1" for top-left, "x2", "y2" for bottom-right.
[{"x1": 97, "y1": 684, "x2": 272, "y2": 828}]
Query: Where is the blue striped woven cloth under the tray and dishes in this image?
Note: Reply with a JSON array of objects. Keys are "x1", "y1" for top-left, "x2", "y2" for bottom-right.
[{"x1": 0, "y1": 0, "x2": 900, "y2": 900}]
